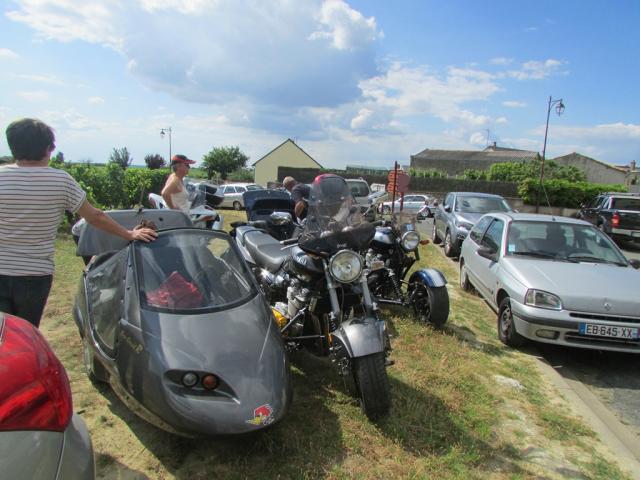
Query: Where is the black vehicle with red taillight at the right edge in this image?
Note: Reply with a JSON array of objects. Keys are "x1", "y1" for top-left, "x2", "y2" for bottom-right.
[{"x1": 577, "y1": 192, "x2": 640, "y2": 243}]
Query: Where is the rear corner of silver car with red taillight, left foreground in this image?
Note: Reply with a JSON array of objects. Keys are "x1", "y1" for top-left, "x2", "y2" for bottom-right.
[{"x1": 0, "y1": 312, "x2": 95, "y2": 480}]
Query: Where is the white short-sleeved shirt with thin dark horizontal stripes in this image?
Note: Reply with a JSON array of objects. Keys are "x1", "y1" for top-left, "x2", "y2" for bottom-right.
[{"x1": 0, "y1": 164, "x2": 86, "y2": 276}]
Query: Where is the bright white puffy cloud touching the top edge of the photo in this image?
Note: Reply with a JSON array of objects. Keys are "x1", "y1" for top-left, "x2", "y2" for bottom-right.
[{"x1": 309, "y1": 0, "x2": 382, "y2": 50}]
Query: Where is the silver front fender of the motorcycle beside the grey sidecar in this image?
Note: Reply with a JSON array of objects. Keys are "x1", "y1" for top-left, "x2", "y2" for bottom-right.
[{"x1": 332, "y1": 317, "x2": 385, "y2": 358}]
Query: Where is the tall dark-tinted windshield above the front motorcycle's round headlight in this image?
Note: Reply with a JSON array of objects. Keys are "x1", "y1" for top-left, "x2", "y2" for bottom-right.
[{"x1": 298, "y1": 174, "x2": 375, "y2": 257}]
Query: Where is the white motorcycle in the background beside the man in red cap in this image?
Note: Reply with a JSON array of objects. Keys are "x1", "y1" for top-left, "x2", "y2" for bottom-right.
[{"x1": 148, "y1": 178, "x2": 224, "y2": 230}]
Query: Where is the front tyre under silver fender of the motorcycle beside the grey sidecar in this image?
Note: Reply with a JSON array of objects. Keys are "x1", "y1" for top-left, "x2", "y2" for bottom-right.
[{"x1": 352, "y1": 352, "x2": 391, "y2": 420}]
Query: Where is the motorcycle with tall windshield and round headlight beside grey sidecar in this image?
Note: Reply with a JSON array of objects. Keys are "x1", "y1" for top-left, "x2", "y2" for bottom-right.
[{"x1": 232, "y1": 174, "x2": 391, "y2": 420}]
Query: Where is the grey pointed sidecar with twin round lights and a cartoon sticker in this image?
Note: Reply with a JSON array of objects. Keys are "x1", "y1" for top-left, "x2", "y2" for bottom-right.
[{"x1": 73, "y1": 209, "x2": 293, "y2": 437}]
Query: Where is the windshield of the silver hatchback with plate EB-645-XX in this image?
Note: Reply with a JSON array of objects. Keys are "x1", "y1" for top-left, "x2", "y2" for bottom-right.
[{"x1": 507, "y1": 221, "x2": 627, "y2": 266}]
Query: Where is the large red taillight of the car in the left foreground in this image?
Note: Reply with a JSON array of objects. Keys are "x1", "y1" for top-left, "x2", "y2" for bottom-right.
[{"x1": 0, "y1": 313, "x2": 73, "y2": 432}]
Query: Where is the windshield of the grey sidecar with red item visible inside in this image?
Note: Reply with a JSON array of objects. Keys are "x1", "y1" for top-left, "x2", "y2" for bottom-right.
[{"x1": 135, "y1": 229, "x2": 256, "y2": 313}]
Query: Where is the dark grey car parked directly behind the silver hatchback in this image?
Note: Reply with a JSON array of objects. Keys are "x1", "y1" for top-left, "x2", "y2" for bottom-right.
[{"x1": 431, "y1": 192, "x2": 511, "y2": 257}]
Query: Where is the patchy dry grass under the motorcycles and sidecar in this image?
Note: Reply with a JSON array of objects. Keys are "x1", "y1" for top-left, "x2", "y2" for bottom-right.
[{"x1": 41, "y1": 219, "x2": 626, "y2": 479}]
